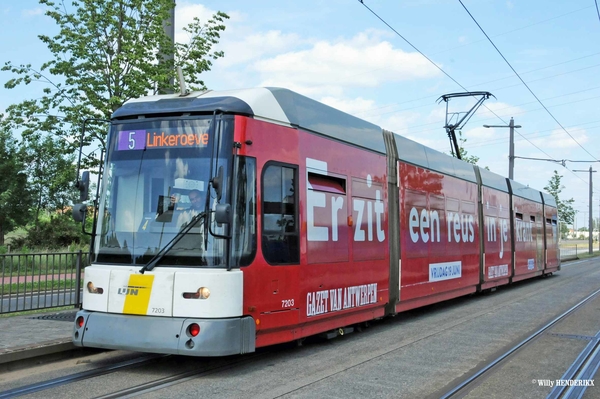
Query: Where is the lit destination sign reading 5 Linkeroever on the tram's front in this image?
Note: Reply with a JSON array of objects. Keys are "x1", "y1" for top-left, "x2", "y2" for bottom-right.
[{"x1": 117, "y1": 129, "x2": 208, "y2": 151}]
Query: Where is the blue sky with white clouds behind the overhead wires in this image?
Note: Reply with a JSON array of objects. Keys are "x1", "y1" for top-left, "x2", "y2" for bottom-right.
[{"x1": 0, "y1": 0, "x2": 600, "y2": 227}]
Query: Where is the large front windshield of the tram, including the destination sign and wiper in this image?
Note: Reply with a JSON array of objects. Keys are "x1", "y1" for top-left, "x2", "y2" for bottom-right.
[{"x1": 94, "y1": 116, "x2": 233, "y2": 267}]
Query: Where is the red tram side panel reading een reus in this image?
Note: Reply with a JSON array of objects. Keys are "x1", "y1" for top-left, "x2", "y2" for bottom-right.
[{"x1": 399, "y1": 163, "x2": 480, "y2": 309}]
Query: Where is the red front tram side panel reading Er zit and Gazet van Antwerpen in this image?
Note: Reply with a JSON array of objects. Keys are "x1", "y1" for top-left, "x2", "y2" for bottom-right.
[{"x1": 238, "y1": 117, "x2": 390, "y2": 346}]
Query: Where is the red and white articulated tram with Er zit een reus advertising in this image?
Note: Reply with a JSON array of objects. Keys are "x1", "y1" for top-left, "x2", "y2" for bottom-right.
[{"x1": 73, "y1": 88, "x2": 560, "y2": 356}]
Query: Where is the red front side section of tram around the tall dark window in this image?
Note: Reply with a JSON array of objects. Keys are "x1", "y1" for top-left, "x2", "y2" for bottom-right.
[{"x1": 240, "y1": 119, "x2": 300, "y2": 336}]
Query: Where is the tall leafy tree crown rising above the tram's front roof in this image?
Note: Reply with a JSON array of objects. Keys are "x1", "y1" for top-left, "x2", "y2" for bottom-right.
[{"x1": 2, "y1": 0, "x2": 229, "y2": 161}]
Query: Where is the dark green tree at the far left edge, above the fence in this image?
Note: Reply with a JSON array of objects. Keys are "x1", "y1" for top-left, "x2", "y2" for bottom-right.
[{"x1": 0, "y1": 125, "x2": 31, "y2": 245}]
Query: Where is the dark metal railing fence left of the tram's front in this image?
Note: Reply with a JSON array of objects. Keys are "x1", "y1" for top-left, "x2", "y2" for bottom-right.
[{"x1": 0, "y1": 251, "x2": 88, "y2": 314}]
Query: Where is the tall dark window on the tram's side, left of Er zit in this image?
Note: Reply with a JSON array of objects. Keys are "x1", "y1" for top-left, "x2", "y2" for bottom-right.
[{"x1": 262, "y1": 164, "x2": 300, "y2": 264}]
